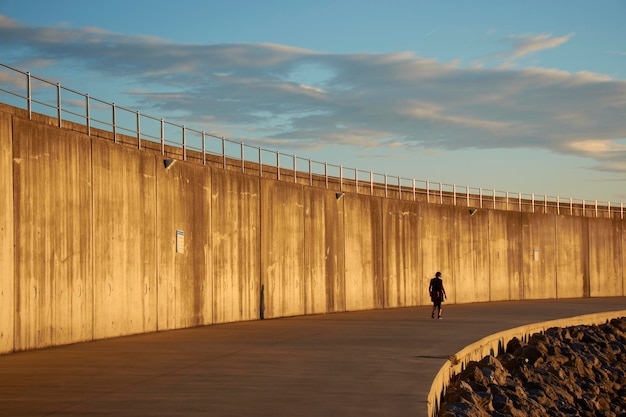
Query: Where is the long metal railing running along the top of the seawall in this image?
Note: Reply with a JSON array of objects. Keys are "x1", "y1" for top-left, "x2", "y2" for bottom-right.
[{"x1": 0, "y1": 63, "x2": 624, "y2": 219}]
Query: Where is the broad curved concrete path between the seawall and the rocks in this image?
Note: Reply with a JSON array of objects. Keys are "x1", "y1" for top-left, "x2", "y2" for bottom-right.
[{"x1": 0, "y1": 297, "x2": 626, "y2": 417}]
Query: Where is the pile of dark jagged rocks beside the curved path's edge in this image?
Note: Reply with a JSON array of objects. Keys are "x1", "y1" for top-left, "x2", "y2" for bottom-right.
[{"x1": 439, "y1": 317, "x2": 626, "y2": 417}]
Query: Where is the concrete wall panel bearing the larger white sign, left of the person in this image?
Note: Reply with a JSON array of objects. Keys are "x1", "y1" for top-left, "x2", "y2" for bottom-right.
[{"x1": 153, "y1": 154, "x2": 213, "y2": 330}]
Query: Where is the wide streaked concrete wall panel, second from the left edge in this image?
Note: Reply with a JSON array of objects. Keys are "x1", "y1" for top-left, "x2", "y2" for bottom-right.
[{"x1": 11, "y1": 118, "x2": 93, "y2": 350}]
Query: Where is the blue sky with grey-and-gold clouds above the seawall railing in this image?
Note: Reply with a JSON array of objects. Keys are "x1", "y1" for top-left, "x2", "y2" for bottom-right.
[{"x1": 0, "y1": 0, "x2": 626, "y2": 204}]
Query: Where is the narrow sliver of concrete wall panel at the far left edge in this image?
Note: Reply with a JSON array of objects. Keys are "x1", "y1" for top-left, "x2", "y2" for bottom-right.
[{"x1": 0, "y1": 112, "x2": 15, "y2": 354}]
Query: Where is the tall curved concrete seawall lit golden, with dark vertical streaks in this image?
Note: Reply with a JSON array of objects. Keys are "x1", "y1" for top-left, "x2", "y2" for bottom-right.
[{"x1": 0, "y1": 105, "x2": 626, "y2": 353}]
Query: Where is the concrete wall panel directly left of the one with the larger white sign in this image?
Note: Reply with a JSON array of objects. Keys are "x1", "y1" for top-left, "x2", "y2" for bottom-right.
[{"x1": 87, "y1": 140, "x2": 157, "y2": 339}]
